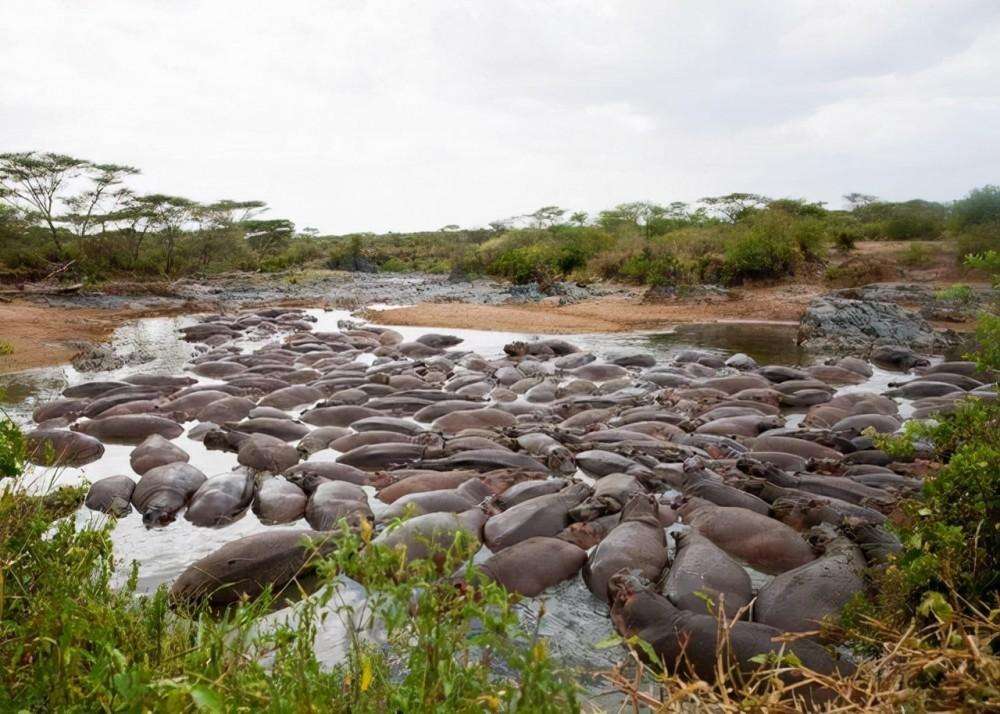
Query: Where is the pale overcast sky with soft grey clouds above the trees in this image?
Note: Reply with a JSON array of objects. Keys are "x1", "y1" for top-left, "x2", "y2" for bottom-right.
[{"x1": 0, "y1": 0, "x2": 1000, "y2": 233}]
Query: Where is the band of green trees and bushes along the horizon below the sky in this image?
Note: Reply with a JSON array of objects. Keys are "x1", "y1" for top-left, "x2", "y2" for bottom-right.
[{"x1": 0, "y1": 152, "x2": 1000, "y2": 285}]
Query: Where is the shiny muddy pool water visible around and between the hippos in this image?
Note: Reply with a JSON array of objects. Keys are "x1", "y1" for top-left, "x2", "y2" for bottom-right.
[{"x1": 0, "y1": 310, "x2": 924, "y2": 672}]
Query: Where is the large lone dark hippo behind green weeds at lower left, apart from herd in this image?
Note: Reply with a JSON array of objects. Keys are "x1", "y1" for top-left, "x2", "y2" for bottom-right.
[{"x1": 170, "y1": 529, "x2": 336, "y2": 608}]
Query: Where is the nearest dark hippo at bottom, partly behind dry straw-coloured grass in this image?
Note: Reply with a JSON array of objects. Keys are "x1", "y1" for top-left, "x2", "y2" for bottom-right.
[{"x1": 609, "y1": 572, "x2": 853, "y2": 705}]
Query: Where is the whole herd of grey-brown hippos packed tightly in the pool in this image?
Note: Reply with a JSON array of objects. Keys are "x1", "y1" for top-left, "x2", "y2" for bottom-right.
[{"x1": 19, "y1": 308, "x2": 996, "y2": 700}]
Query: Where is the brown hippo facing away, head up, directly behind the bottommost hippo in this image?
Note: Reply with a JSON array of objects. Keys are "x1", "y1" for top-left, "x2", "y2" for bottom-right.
[{"x1": 583, "y1": 494, "x2": 667, "y2": 602}]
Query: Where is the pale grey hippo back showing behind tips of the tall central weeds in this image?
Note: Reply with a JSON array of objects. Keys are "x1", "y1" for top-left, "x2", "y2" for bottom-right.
[{"x1": 372, "y1": 508, "x2": 486, "y2": 567}]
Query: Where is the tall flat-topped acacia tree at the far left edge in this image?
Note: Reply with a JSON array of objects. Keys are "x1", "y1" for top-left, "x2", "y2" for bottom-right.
[{"x1": 0, "y1": 151, "x2": 92, "y2": 252}]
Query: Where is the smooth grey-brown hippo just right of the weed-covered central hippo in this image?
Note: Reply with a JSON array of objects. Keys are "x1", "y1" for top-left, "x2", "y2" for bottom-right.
[{"x1": 484, "y1": 483, "x2": 590, "y2": 552}]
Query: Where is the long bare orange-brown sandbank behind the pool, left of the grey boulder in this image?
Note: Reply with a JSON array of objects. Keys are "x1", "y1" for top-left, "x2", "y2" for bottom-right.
[{"x1": 364, "y1": 284, "x2": 822, "y2": 334}]
